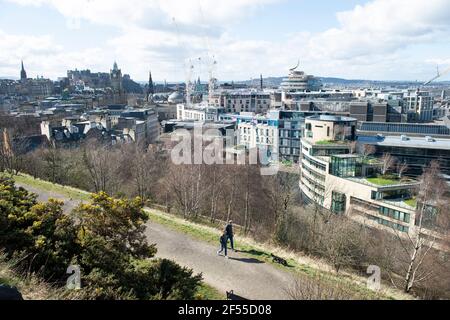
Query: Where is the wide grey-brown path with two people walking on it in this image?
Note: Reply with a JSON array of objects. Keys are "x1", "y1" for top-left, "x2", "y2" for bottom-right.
[{"x1": 17, "y1": 184, "x2": 292, "y2": 300}]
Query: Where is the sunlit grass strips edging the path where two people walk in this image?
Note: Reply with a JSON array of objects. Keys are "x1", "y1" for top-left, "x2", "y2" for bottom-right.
[{"x1": 8, "y1": 175, "x2": 411, "y2": 300}]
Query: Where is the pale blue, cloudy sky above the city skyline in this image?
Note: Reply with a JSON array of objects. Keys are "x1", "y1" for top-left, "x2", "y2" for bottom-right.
[{"x1": 0, "y1": 0, "x2": 450, "y2": 81}]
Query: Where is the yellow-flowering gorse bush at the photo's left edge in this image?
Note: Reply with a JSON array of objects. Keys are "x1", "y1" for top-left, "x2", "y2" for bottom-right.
[{"x1": 0, "y1": 177, "x2": 77, "y2": 280}]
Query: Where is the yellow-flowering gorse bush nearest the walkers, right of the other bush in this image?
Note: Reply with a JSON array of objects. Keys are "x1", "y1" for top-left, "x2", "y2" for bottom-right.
[{"x1": 75, "y1": 192, "x2": 201, "y2": 299}]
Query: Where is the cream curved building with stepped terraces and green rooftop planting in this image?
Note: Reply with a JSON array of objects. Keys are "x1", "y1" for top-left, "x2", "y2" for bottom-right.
[{"x1": 300, "y1": 116, "x2": 440, "y2": 237}]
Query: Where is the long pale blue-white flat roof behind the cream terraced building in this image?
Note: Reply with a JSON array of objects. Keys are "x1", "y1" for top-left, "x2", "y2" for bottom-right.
[{"x1": 358, "y1": 136, "x2": 450, "y2": 150}]
